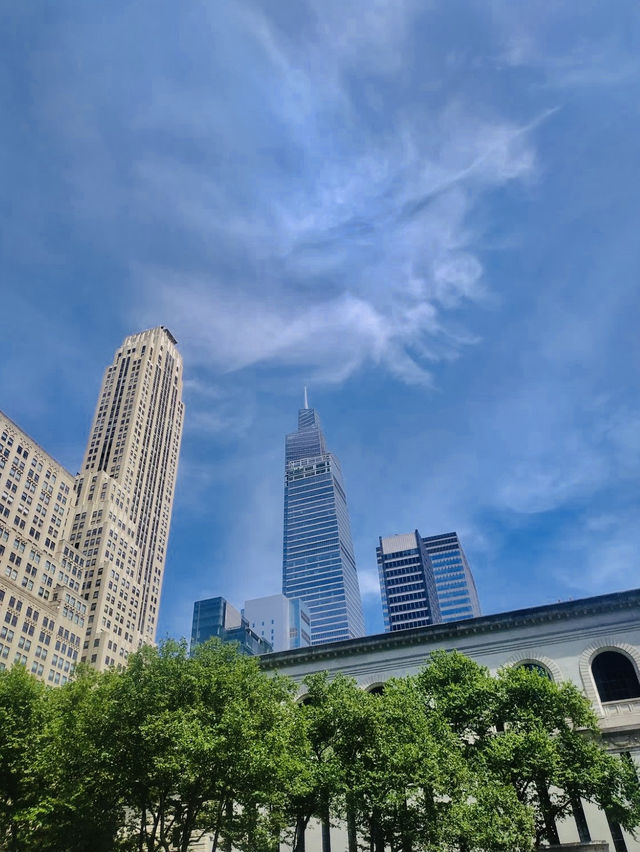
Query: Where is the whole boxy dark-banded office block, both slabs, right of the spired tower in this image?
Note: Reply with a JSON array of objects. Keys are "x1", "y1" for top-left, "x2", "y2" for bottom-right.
[{"x1": 376, "y1": 530, "x2": 480, "y2": 631}]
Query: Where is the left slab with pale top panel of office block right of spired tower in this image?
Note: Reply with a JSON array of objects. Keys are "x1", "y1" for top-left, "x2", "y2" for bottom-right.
[{"x1": 376, "y1": 530, "x2": 442, "y2": 632}]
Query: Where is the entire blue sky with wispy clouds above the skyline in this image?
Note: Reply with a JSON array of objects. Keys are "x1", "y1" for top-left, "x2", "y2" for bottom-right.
[{"x1": 0, "y1": 0, "x2": 640, "y2": 636}]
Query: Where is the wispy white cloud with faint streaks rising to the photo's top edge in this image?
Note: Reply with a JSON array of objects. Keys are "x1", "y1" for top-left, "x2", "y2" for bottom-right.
[{"x1": 130, "y1": 3, "x2": 548, "y2": 385}]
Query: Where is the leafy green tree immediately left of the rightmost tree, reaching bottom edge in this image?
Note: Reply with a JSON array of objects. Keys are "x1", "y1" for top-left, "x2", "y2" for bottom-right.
[{"x1": 344, "y1": 678, "x2": 532, "y2": 852}]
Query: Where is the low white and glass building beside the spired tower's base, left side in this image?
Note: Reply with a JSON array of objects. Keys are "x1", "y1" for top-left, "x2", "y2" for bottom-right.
[{"x1": 242, "y1": 595, "x2": 311, "y2": 651}]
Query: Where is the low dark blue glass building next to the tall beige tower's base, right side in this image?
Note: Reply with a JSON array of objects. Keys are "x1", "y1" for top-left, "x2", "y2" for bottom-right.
[{"x1": 191, "y1": 597, "x2": 272, "y2": 655}]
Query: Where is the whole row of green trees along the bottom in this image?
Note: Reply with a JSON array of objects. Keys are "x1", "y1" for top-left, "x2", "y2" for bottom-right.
[{"x1": 0, "y1": 641, "x2": 640, "y2": 852}]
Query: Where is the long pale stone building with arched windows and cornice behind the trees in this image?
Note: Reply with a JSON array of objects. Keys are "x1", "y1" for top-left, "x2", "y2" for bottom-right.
[{"x1": 262, "y1": 590, "x2": 640, "y2": 852}]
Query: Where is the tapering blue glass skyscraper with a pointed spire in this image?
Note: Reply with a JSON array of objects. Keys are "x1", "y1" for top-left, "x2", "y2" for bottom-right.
[{"x1": 282, "y1": 390, "x2": 364, "y2": 645}]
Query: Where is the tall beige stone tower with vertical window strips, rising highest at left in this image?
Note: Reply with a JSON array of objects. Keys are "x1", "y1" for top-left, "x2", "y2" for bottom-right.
[{"x1": 75, "y1": 327, "x2": 184, "y2": 669}]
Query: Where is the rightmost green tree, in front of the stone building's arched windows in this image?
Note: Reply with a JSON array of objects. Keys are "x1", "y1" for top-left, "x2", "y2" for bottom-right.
[{"x1": 417, "y1": 652, "x2": 640, "y2": 844}]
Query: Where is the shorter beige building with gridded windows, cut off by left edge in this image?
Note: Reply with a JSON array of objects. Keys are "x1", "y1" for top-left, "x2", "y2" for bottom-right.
[{"x1": 0, "y1": 412, "x2": 89, "y2": 685}]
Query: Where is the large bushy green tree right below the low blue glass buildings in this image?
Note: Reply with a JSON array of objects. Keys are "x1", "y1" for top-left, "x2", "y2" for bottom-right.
[{"x1": 112, "y1": 641, "x2": 294, "y2": 852}]
